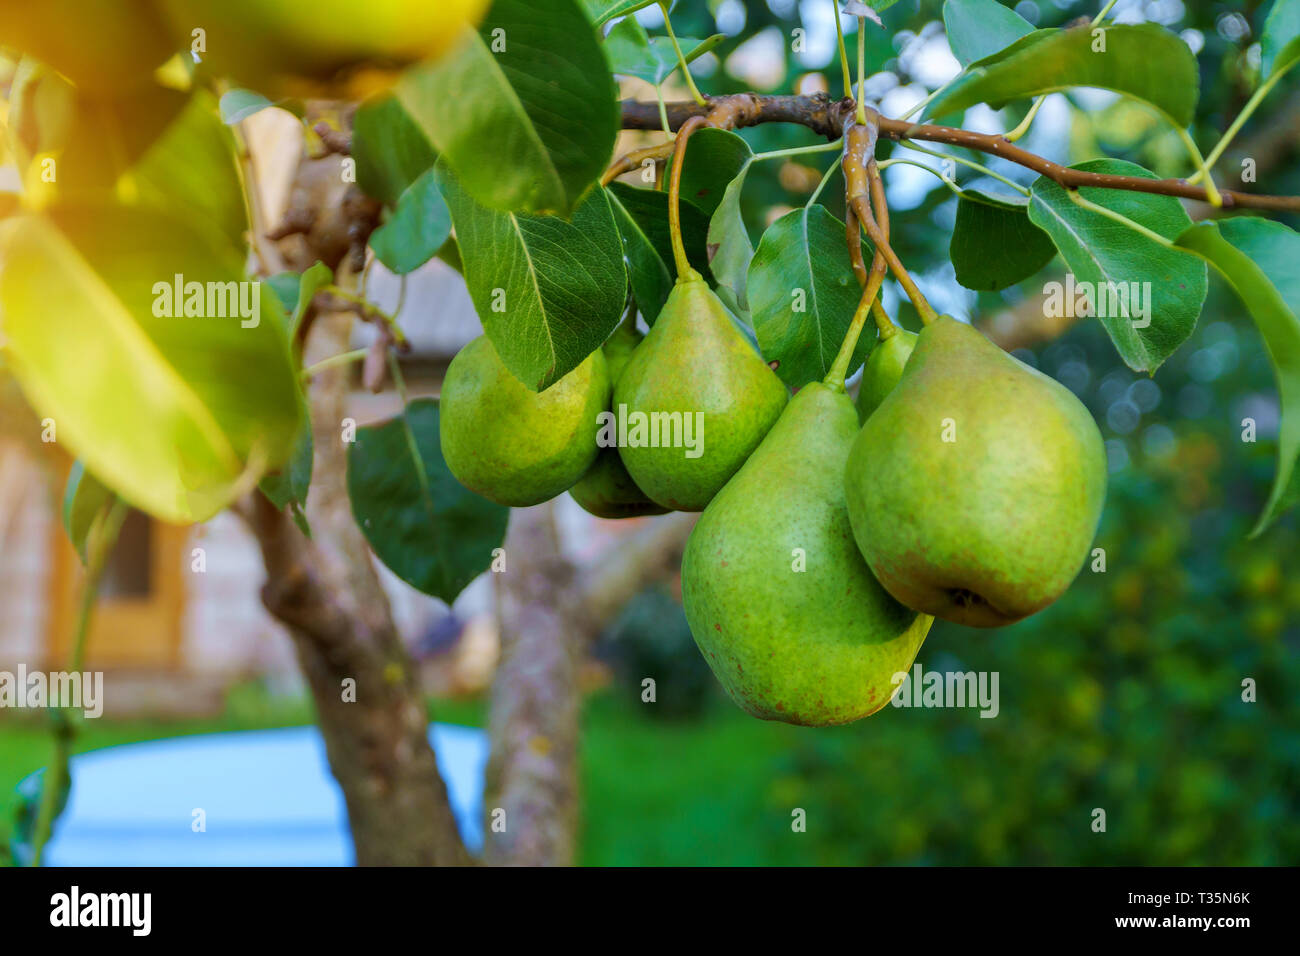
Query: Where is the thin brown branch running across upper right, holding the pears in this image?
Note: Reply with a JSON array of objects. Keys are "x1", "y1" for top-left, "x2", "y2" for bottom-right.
[{"x1": 623, "y1": 94, "x2": 1300, "y2": 212}]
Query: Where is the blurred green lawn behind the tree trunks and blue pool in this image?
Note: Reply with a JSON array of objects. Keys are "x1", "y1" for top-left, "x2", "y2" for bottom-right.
[{"x1": 0, "y1": 688, "x2": 800, "y2": 865}]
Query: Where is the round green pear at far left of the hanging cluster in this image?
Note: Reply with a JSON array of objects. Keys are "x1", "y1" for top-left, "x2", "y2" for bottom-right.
[{"x1": 439, "y1": 336, "x2": 610, "y2": 507}]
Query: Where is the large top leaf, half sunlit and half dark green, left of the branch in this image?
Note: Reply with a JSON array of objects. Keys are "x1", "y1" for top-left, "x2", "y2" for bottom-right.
[{"x1": 398, "y1": 0, "x2": 620, "y2": 215}]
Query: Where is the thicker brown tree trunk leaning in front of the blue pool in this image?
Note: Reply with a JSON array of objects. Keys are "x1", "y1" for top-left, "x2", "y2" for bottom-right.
[{"x1": 246, "y1": 306, "x2": 469, "y2": 866}]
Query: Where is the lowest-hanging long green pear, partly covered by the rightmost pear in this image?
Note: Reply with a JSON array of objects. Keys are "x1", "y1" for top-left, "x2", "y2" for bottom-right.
[{"x1": 681, "y1": 382, "x2": 932, "y2": 727}]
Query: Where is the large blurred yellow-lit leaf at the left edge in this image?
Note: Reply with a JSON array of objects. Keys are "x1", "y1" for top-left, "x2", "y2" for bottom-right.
[{"x1": 0, "y1": 206, "x2": 299, "y2": 523}]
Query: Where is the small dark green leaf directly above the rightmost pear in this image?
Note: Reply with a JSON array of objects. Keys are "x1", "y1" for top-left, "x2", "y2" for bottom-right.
[{"x1": 948, "y1": 189, "x2": 1056, "y2": 293}]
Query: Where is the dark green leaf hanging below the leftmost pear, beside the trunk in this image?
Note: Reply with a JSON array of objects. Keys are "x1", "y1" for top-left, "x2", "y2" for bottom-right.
[{"x1": 347, "y1": 398, "x2": 510, "y2": 604}]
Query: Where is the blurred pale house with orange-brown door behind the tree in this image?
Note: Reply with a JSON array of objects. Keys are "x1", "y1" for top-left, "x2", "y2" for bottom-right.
[{"x1": 0, "y1": 260, "x2": 497, "y2": 713}]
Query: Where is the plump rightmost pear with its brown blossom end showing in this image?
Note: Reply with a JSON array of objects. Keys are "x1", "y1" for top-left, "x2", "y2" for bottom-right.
[{"x1": 845, "y1": 316, "x2": 1106, "y2": 627}]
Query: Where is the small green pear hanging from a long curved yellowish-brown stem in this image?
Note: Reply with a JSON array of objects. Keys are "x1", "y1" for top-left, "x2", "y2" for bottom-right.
[{"x1": 614, "y1": 271, "x2": 789, "y2": 511}]
